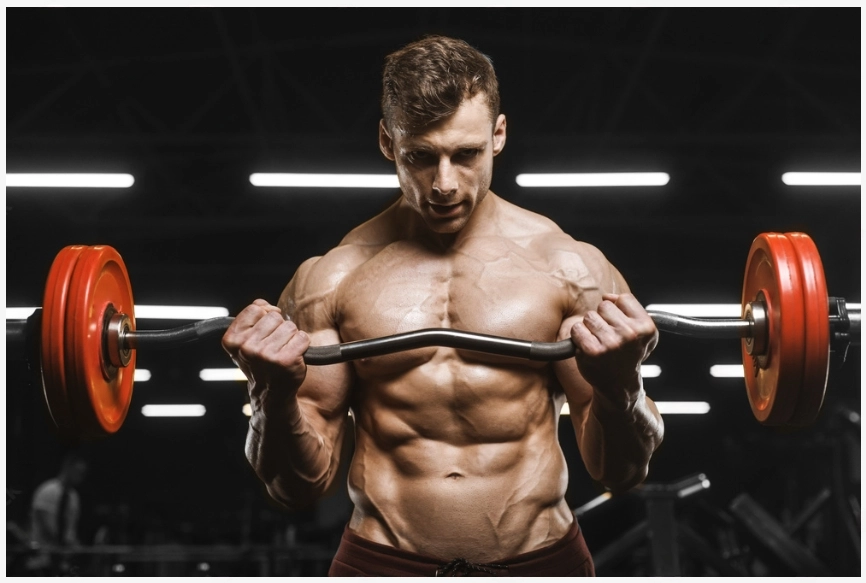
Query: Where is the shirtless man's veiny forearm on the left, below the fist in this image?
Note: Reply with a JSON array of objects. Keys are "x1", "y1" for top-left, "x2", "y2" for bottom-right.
[{"x1": 246, "y1": 397, "x2": 337, "y2": 507}]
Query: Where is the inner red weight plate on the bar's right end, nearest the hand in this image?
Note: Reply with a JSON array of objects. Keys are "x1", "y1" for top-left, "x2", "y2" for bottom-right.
[{"x1": 742, "y1": 233, "x2": 806, "y2": 425}]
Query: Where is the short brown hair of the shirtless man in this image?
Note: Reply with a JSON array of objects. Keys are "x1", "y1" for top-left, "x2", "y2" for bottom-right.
[{"x1": 382, "y1": 36, "x2": 499, "y2": 129}]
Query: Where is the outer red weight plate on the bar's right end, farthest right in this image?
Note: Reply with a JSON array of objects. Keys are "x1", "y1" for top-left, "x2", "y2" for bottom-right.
[{"x1": 786, "y1": 233, "x2": 830, "y2": 427}]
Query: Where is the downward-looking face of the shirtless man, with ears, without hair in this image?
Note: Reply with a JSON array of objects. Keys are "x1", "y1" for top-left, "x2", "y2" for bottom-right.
[{"x1": 379, "y1": 94, "x2": 505, "y2": 234}]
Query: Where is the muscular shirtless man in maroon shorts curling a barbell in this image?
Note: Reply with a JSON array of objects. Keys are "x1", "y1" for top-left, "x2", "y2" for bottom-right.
[{"x1": 223, "y1": 37, "x2": 663, "y2": 576}]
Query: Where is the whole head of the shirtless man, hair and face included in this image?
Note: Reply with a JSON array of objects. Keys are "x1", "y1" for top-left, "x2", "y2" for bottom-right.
[{"x1": 379, "y1": 37, "x2": 505, "y2": 234}]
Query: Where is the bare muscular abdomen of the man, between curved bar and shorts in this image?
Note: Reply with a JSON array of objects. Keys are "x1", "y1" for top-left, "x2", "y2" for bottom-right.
[{"x1": 349, "y1": 359, "x2": 573, "y2": 562}]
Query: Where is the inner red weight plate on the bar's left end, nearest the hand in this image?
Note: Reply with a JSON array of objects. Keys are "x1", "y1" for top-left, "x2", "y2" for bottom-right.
[{"x1": 66, "y1": 245, "x2": 135, "y2": 437}]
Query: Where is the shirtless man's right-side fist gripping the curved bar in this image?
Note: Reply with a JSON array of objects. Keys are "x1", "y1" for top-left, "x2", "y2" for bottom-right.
[{"x1": 571, "y1": 294, "x2": 658, "y2": 409}]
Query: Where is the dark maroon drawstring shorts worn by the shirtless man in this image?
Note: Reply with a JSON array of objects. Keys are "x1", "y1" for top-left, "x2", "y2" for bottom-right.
[{"x1": 328, "y1": 521, "x2": 595, "y2": 577}]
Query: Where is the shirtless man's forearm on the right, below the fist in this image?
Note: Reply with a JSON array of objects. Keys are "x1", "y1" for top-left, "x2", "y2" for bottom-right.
[{"x1": 580, "y1": 388, "x2": 664, "y2": 491}]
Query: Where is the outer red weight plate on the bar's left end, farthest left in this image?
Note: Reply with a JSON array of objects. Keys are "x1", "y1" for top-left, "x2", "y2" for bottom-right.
[{"x1": 39, "y1": 245, "x2": 84, "y2": 430}]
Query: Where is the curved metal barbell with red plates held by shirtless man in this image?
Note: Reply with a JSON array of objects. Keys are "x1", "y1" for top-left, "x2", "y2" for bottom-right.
[{"x1": 6, "y1": 233, "x2": 860, "y2": 437}]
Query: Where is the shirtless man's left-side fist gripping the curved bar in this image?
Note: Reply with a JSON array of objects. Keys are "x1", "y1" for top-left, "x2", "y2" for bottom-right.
[{"x1": 222, "y1": 300, "x2": 310, "y2": 411}]
